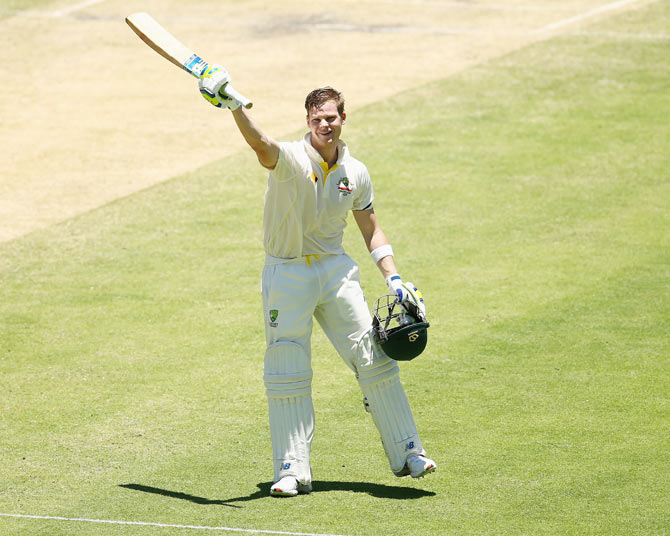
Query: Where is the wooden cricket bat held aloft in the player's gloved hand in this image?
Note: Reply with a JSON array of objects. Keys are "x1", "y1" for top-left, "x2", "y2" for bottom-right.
[{"x1": 126, "y1": 13, "x2": 253, "y2": 108}]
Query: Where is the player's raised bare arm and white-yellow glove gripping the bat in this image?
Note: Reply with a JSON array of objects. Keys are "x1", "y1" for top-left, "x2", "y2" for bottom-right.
[{"x1": 198, "y1": 65, "x2": 279, "y2": 169}]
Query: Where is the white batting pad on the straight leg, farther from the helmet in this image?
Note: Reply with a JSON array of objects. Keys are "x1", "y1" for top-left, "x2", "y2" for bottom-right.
[{"x1": 263, "y1": 341, "x2": 314, "y2": 484}]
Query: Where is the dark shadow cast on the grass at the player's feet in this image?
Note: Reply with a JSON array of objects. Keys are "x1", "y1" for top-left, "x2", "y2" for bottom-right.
[{"x1": 119, "y1": 480, "x2": 435, "y2": 508}]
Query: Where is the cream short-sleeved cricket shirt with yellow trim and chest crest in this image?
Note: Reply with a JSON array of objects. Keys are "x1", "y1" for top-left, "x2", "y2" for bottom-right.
[{"x1": 263, "y1": 132, "x2": 374, "y2": 260}]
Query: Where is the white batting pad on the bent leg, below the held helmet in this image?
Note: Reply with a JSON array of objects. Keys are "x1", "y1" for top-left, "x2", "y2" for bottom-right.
[{"x1": 357, "y1": 349, "x2": 425, "y2": 473}]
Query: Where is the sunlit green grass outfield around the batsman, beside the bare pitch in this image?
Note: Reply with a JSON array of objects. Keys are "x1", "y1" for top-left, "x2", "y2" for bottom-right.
[{"x1": 0, "y1": 1, "x2": 670, "y2": 536}]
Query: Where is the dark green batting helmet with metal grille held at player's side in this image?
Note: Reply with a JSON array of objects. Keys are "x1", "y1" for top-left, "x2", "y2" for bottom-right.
[{"x1": 372, "y1": 294, "x2": 430, "y2": 361}]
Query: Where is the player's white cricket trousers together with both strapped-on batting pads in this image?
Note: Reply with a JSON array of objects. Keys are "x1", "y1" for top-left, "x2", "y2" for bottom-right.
[{"x1": 262, "y1": 254, "x2": 423, "y2": 484}]
